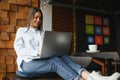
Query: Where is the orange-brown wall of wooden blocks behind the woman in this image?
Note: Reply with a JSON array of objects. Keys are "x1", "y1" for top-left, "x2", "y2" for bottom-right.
[{"x1": 0, "y1": 0, "x2": 40, "y2": 76}]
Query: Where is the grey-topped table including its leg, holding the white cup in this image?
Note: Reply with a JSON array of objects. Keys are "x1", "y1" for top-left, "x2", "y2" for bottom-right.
[{"x1": 74, "y1": 52, "x2": 120, "y2": 75}]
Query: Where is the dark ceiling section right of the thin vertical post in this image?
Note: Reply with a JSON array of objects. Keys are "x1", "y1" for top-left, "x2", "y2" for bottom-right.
[{"x1": 76, "y1": 0, "x2": 120, "y2": 13}]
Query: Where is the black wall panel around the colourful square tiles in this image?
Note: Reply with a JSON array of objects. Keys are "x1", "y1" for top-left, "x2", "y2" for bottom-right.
[{"x1": 76, "y1": 10, "x2": 116, "y2": 52}]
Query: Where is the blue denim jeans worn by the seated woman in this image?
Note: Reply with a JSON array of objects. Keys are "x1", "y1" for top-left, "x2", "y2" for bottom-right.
[{"x1": 22, "y1": 55, "x2": 86, "y2": 80}]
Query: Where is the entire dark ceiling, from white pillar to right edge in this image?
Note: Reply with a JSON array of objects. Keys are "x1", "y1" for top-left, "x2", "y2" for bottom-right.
[{"x1": 51, "y1": 0, "x2": 120, "y2": 14}]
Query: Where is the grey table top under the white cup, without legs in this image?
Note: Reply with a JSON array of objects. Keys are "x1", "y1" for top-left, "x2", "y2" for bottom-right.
[{"x1": 74, "y1": 52, "x2": 120, "y2": 59}]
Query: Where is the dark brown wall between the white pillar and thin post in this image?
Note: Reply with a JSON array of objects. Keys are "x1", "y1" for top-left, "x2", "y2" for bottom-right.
[{"x1": 52, "y1": 6, "x2": 74, "y2": 53}]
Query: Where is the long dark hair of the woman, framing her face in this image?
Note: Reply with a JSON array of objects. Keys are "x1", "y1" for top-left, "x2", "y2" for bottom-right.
[{"x1": 26, "y1": 7, "x2": 43, "y2": 31}]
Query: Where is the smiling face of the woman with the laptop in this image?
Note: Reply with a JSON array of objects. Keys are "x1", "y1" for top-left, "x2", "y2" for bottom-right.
[{"x1": 30, "y1": 12, "x2": 42, "y2": 28}]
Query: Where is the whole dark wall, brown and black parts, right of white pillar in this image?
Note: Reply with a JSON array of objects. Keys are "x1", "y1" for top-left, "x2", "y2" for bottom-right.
[{"x1": 53, "y1": 3, "x2": 120, "y2": 52}]
